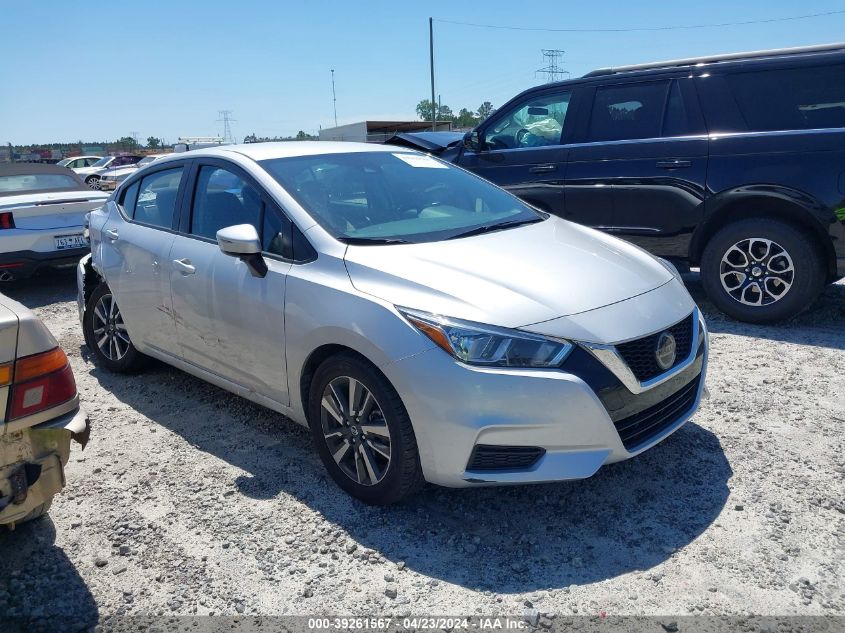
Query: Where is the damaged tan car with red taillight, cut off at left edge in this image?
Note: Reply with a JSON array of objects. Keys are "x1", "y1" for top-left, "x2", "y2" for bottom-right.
[{"x1": 0, "y1": 294, "x2": 89, "y2": 527}]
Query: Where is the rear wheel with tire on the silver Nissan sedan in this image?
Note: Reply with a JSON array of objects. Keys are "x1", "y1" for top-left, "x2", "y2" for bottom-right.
[{"x1": 82, "y1": 282, "x2": 148, "y2": 373}]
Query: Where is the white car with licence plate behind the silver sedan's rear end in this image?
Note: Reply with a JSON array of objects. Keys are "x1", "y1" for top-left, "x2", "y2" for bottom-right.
[{"x1": 0, "y1": 163, "x2": 108, "y2": 281}]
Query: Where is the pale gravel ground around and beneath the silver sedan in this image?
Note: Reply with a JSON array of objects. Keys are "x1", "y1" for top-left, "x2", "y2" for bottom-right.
[{"x1": 0, "y1": 275, "x2": 845, "y2": 625}]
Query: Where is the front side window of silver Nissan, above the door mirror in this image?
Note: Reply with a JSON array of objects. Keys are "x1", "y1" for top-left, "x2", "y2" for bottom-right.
[{"x1": 191, "y1": 165, "x2": 262, "y2": 240}]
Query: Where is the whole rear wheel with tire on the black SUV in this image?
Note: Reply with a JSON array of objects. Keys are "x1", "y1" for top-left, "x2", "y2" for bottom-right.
[{"x1": 701, "y1": 218, "x2": 825, "y2": 323}]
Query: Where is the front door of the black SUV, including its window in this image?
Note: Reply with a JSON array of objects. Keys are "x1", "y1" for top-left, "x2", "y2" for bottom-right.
[{"x1": 457, "y1": 87, "x2": 573, "y2": 214}]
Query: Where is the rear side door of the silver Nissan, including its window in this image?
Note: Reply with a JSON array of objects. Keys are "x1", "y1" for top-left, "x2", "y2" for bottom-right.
[{"x1": 101, "y1": 161, "x2": 187, "y2": 355}]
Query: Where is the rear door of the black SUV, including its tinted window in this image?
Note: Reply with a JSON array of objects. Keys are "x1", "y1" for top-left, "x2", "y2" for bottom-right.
[{"x1": 566, "y1": 78, "x2": 708, "y2": 252}]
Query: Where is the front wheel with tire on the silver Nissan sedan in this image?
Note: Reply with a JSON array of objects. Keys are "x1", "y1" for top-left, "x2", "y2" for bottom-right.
[{"x1": 308, "y1": 354, "x2": 424, "y2": 505}]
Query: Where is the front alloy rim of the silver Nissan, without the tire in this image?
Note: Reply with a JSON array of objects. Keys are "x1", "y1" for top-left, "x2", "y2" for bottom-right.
[{"x1": 320, "y1": 376, "x2": 391, "y2": 486}]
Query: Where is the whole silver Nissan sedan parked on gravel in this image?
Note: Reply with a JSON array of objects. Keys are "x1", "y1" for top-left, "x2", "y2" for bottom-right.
[{"x1": 78, "y1": 142, "x2": 707, "y2": 504}]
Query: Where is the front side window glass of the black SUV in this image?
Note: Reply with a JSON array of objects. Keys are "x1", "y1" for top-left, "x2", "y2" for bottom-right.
[{"x1": 484, "y1": 91, "x2": 572, "y2": 150}]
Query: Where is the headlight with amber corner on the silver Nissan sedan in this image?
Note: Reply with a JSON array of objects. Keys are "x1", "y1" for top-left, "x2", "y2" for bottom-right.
[{"x1": 397, "y1": 308, "x2": 573, "y2": 368}]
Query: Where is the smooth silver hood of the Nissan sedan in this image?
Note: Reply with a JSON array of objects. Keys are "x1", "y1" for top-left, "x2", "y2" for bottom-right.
[{"x1": 345, "y1": 217, "x2": 673, "y2": 327}]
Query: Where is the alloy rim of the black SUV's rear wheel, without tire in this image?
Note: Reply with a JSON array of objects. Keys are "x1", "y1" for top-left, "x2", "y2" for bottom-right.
[{"x1": 719, "y1": 237, "x2": 795, "y2": 306}]
